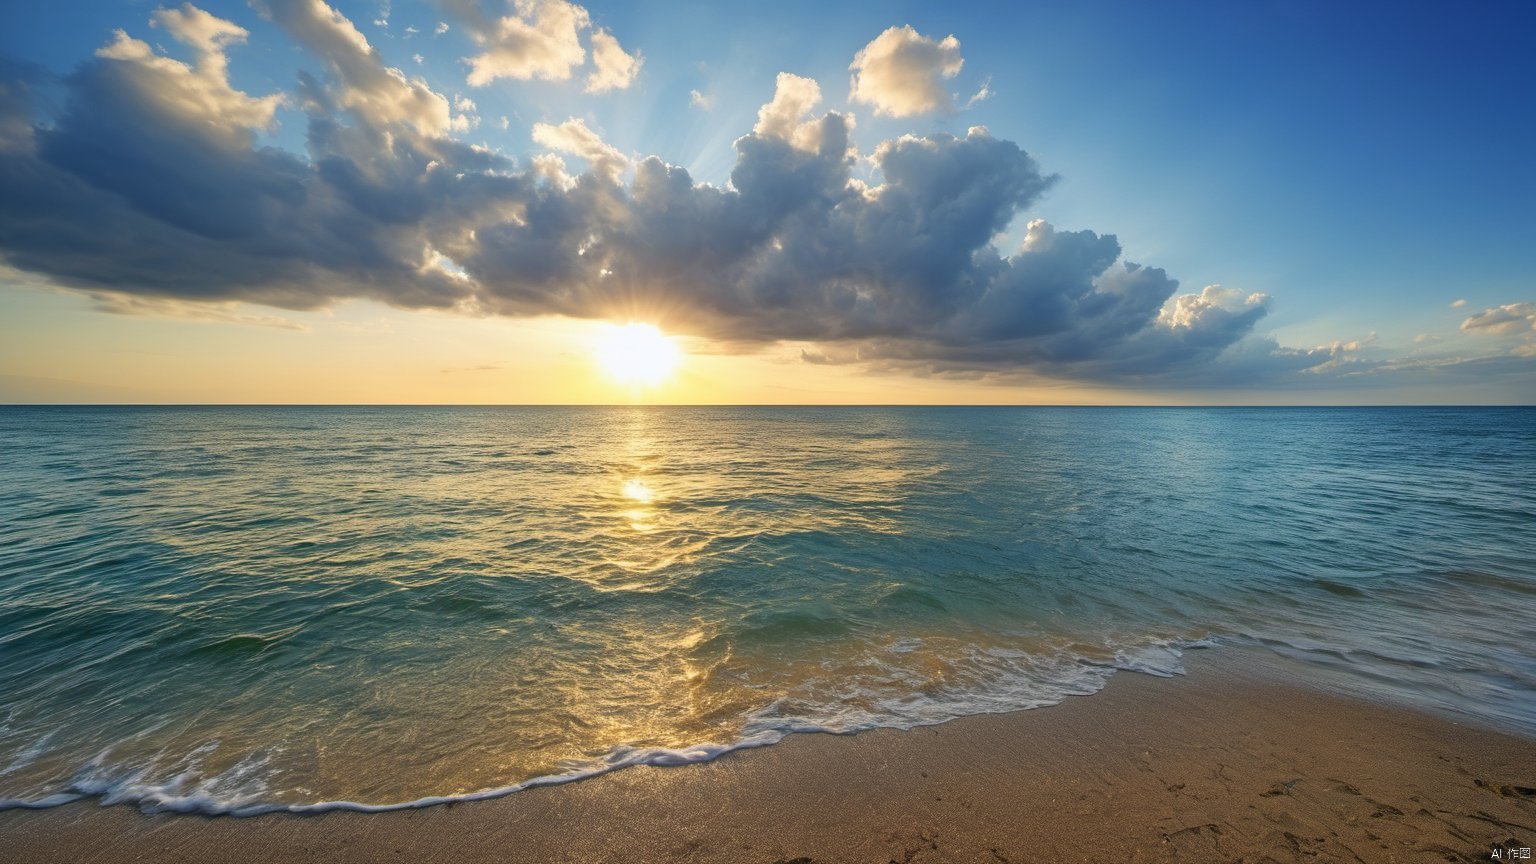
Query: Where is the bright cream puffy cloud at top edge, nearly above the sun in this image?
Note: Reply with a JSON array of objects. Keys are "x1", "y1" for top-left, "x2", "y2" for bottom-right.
[{"x1": 468, "y1": 0, "x2": 591, "y2": 88}]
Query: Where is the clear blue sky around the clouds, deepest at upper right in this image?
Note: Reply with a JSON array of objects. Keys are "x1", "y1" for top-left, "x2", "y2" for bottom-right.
[{"x1": 0, "y1": 2, "x2": 1536, "y2": 401}]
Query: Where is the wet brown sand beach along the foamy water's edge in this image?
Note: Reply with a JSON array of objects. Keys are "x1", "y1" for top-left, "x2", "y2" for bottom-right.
[{"x1": 0, "y1": 649, "x2": 1536, "y2": 864}]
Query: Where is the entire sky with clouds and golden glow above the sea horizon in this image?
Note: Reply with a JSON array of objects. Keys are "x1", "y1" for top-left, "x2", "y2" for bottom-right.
[{"x1": 0, "y1": 0, "x2": 1536, "y2": 404}]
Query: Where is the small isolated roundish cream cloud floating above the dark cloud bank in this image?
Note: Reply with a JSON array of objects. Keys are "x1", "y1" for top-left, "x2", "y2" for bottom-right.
[{"x1": 848, "y1": 25, "x2": 958, "y2": 117}]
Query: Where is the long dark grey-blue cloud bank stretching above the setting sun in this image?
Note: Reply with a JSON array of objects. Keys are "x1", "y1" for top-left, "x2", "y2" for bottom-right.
[{"x1": 0, "y1": 0, "x2": 1329, "y2": 378}]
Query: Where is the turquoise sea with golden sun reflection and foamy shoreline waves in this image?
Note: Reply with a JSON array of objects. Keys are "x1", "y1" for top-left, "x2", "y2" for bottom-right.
[{"x1": 0, "y1": 407, "x2": 1536, "y2": 813}]
